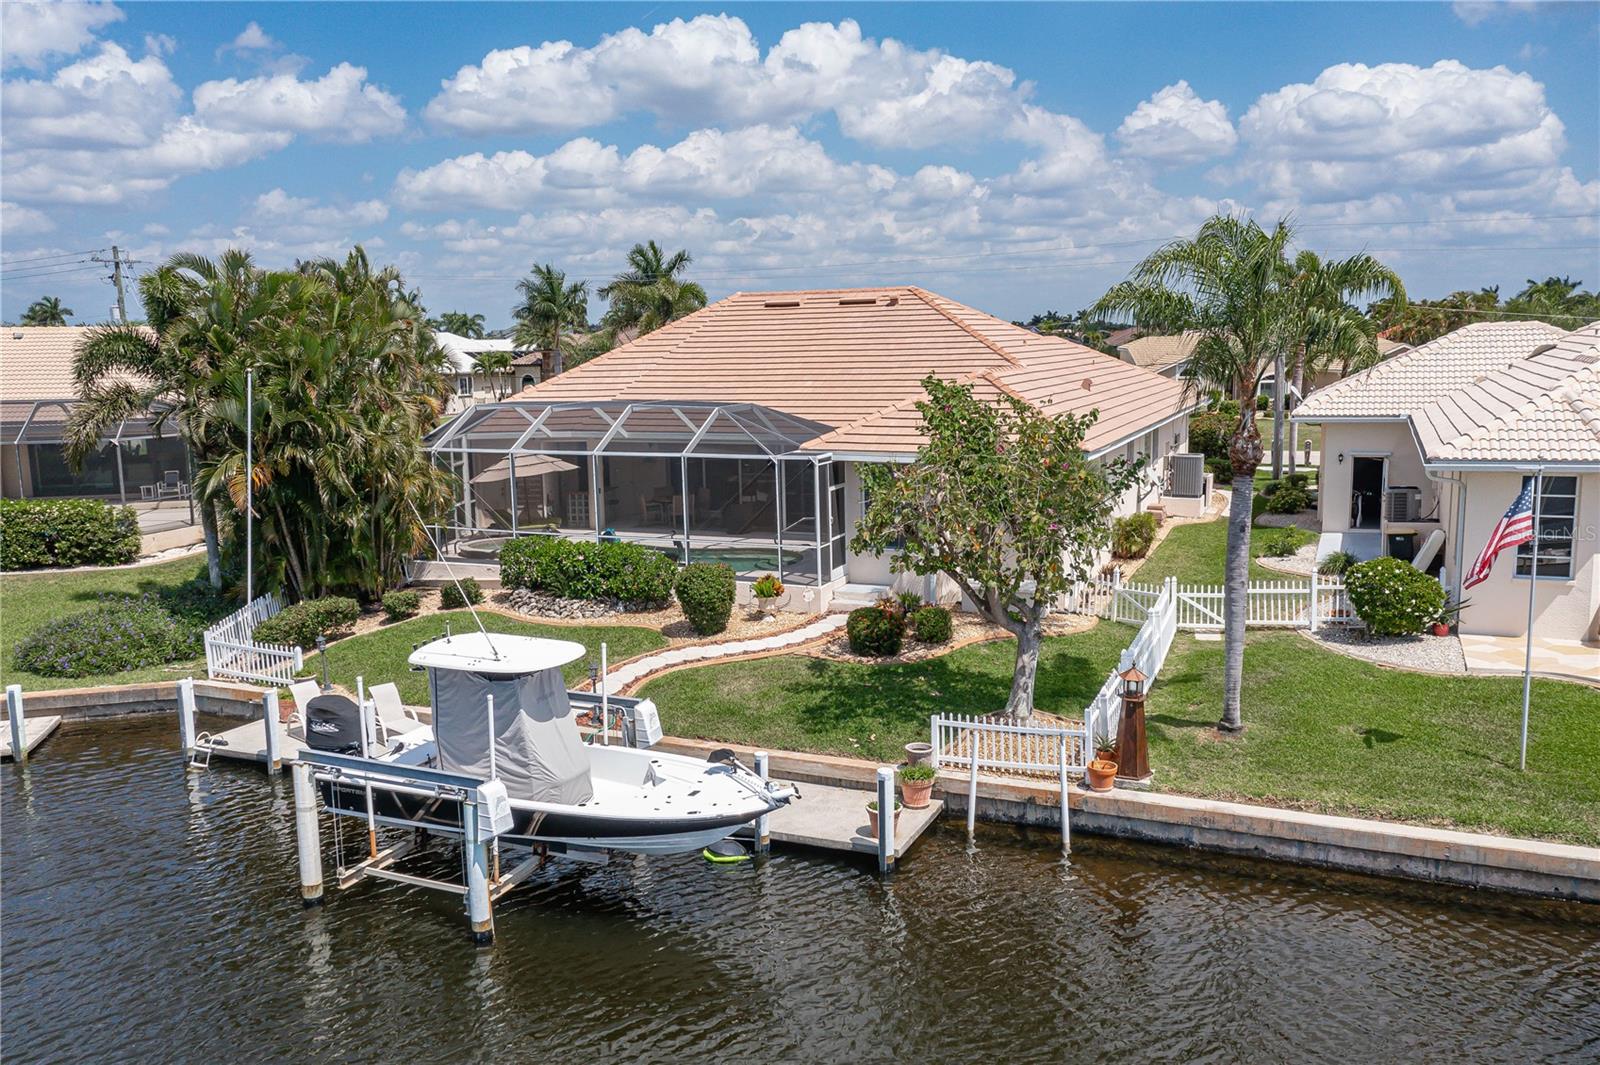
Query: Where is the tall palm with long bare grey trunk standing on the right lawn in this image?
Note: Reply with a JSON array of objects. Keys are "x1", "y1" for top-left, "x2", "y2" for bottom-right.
[{"x1": 1094, "y1": 214, "x2": 1293, "y2": 732}]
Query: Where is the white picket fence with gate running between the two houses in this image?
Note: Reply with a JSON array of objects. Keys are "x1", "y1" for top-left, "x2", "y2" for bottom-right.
[{"x1": 1067, "y1": 574, "x2": 1354, "y2": 632}]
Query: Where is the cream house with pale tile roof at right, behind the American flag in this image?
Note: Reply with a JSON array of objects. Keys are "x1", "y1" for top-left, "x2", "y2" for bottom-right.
[{"x1": 1294, "y1": 321, "x2": 1600, "y2": 641}]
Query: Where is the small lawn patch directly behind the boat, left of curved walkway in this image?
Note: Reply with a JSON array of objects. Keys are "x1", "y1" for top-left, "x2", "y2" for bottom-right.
[{"x1": 306, "y1": 611, "x2": 667, "y2": 707}]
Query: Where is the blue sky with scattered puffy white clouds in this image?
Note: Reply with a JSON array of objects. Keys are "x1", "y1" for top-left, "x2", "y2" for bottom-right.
[{"x1": 0, "y1": 0, "x2": 1600, "y2": 328}]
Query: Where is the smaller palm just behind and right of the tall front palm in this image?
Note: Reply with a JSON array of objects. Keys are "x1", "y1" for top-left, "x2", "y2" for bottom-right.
[{"x1": 1272, "y1": 249, "x2": 1405, "y2": 478}]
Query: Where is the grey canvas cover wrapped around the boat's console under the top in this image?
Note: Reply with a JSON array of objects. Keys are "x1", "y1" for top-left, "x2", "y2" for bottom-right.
[{"x1": 429, "y1": 658, "x2": 594, "y2": 806}]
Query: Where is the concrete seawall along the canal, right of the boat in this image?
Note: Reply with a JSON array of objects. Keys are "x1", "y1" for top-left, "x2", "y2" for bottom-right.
[{"x1": 661, "y1": 737, "x2": 1600, "y2": 902}]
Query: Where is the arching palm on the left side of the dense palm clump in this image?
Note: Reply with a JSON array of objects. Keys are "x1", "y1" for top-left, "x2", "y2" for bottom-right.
[{"x1": 66, "y1": 249, "x2": 298, "y2": 588}]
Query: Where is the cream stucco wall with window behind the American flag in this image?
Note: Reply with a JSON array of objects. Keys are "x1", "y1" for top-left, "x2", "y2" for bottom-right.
[{"x1": 1461, "y1": 473, "x2": 1600, "y2": 640}]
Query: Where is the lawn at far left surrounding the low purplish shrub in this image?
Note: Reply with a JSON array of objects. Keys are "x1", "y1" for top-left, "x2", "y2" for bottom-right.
[{"x1": 0, "y1": 558, "x2": 214, "y2": 691}]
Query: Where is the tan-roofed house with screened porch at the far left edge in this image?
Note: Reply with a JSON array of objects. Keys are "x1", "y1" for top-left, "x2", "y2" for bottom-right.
[{"x1": 0, "y1": 326, "x2": 190, "y2": 502}]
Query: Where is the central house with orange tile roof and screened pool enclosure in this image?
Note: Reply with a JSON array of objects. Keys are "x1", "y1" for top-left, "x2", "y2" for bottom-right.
[{"x1": 429, "y1": 286, "x2": 1205, "y2": 609}]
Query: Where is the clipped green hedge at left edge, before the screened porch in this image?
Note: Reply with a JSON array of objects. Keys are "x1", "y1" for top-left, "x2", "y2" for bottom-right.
[{"x1": 0, "y1": 499, "x2": 139, "y2": 569}]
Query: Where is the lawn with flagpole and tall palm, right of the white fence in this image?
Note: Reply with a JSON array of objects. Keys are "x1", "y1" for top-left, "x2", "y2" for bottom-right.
[{"x1": 1146, "y1": 633, "x2": 1600, "y2": 844}]
